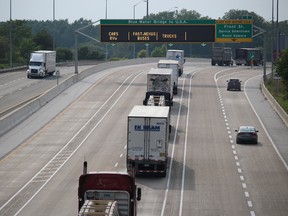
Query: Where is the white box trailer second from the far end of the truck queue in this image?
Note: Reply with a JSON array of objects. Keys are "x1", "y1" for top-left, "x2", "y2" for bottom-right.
[{"x1": 157, "y1": 59, "x2": 180, "y2": 95}]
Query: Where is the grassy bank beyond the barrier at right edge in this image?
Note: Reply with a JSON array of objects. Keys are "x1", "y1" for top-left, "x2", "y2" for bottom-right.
[{"x1": 265, "y1": 78, "x2": 288, "y2": 114}]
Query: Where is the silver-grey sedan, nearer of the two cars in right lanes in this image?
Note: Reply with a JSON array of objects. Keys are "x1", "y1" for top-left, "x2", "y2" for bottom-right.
[{"x1": 235, "y1": 126, "x2": 258, "y2": 144}]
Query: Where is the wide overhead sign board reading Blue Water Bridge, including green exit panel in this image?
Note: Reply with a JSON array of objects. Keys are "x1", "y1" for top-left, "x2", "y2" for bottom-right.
[{"x1": 100, "y1": 19, "x2": 253, "y2": 43}]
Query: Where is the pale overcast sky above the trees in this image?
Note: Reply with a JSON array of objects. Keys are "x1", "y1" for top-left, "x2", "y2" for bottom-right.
[{"x1": 0, "y1": 0, "x2": 288, "y2": 22}]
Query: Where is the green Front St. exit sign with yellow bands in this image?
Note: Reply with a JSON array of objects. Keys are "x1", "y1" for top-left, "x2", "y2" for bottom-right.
[{"x1": 215, "y1": 20, "x2": 253, "y2": 43}]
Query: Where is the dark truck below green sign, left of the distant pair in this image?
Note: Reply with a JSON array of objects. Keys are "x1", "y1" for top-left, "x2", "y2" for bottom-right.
[{"x1": 211, "y1": 47, "x2": 233, "y2": 66}]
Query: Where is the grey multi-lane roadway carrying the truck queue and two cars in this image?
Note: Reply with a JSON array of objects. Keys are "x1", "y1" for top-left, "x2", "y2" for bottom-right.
[{"x1": 0, "y1": 59, "x2": 288, "y2": 216}]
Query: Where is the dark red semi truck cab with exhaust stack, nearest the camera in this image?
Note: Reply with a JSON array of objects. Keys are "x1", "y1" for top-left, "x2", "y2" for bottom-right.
[{"x1": 78, "y1": 161, "x2": 141, "y2": 216}]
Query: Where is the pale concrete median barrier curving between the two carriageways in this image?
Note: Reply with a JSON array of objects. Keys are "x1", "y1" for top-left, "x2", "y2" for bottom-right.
[{"x1": 0, "y1": 58, "x2": 163, "y2": 136}]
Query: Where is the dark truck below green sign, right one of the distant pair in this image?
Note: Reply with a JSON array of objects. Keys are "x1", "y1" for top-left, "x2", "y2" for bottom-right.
[{"x1": 235, "y1": 48, "x2": 263, "y2": 66}]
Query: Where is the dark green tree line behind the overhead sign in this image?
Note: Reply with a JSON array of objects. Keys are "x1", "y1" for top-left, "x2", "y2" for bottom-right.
[{"x1": 0, "y1": 9, "x2": 288, "y2": 68}]
